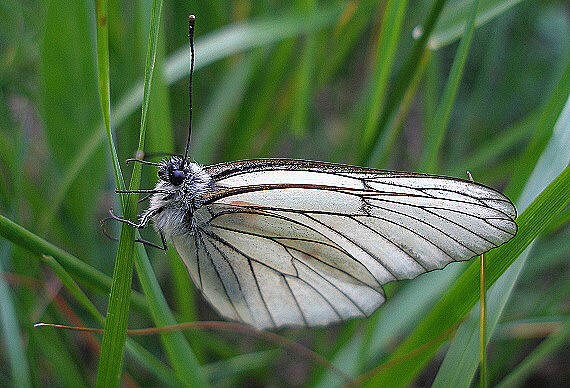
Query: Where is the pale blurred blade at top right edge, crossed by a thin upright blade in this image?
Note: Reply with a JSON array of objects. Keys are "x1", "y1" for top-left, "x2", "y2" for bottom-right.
[{"x1": 429, "y1": 0, "x2": 522, "y2": 50}]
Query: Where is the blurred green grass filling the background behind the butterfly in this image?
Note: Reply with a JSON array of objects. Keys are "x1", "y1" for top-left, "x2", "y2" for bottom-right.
[{"x1": 0, "y1": 0, "x2": 570, "y2": 386}]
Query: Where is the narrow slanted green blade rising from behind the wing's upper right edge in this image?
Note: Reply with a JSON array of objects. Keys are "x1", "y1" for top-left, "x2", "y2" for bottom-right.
[{"x1": 419, "y1": 0, "x2": 479, "y2": 173}]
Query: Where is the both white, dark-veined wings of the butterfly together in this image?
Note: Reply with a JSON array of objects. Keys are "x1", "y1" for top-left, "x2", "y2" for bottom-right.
[{"x1": 169, "y1": 159, "x2": 516, "y2": 328}]
